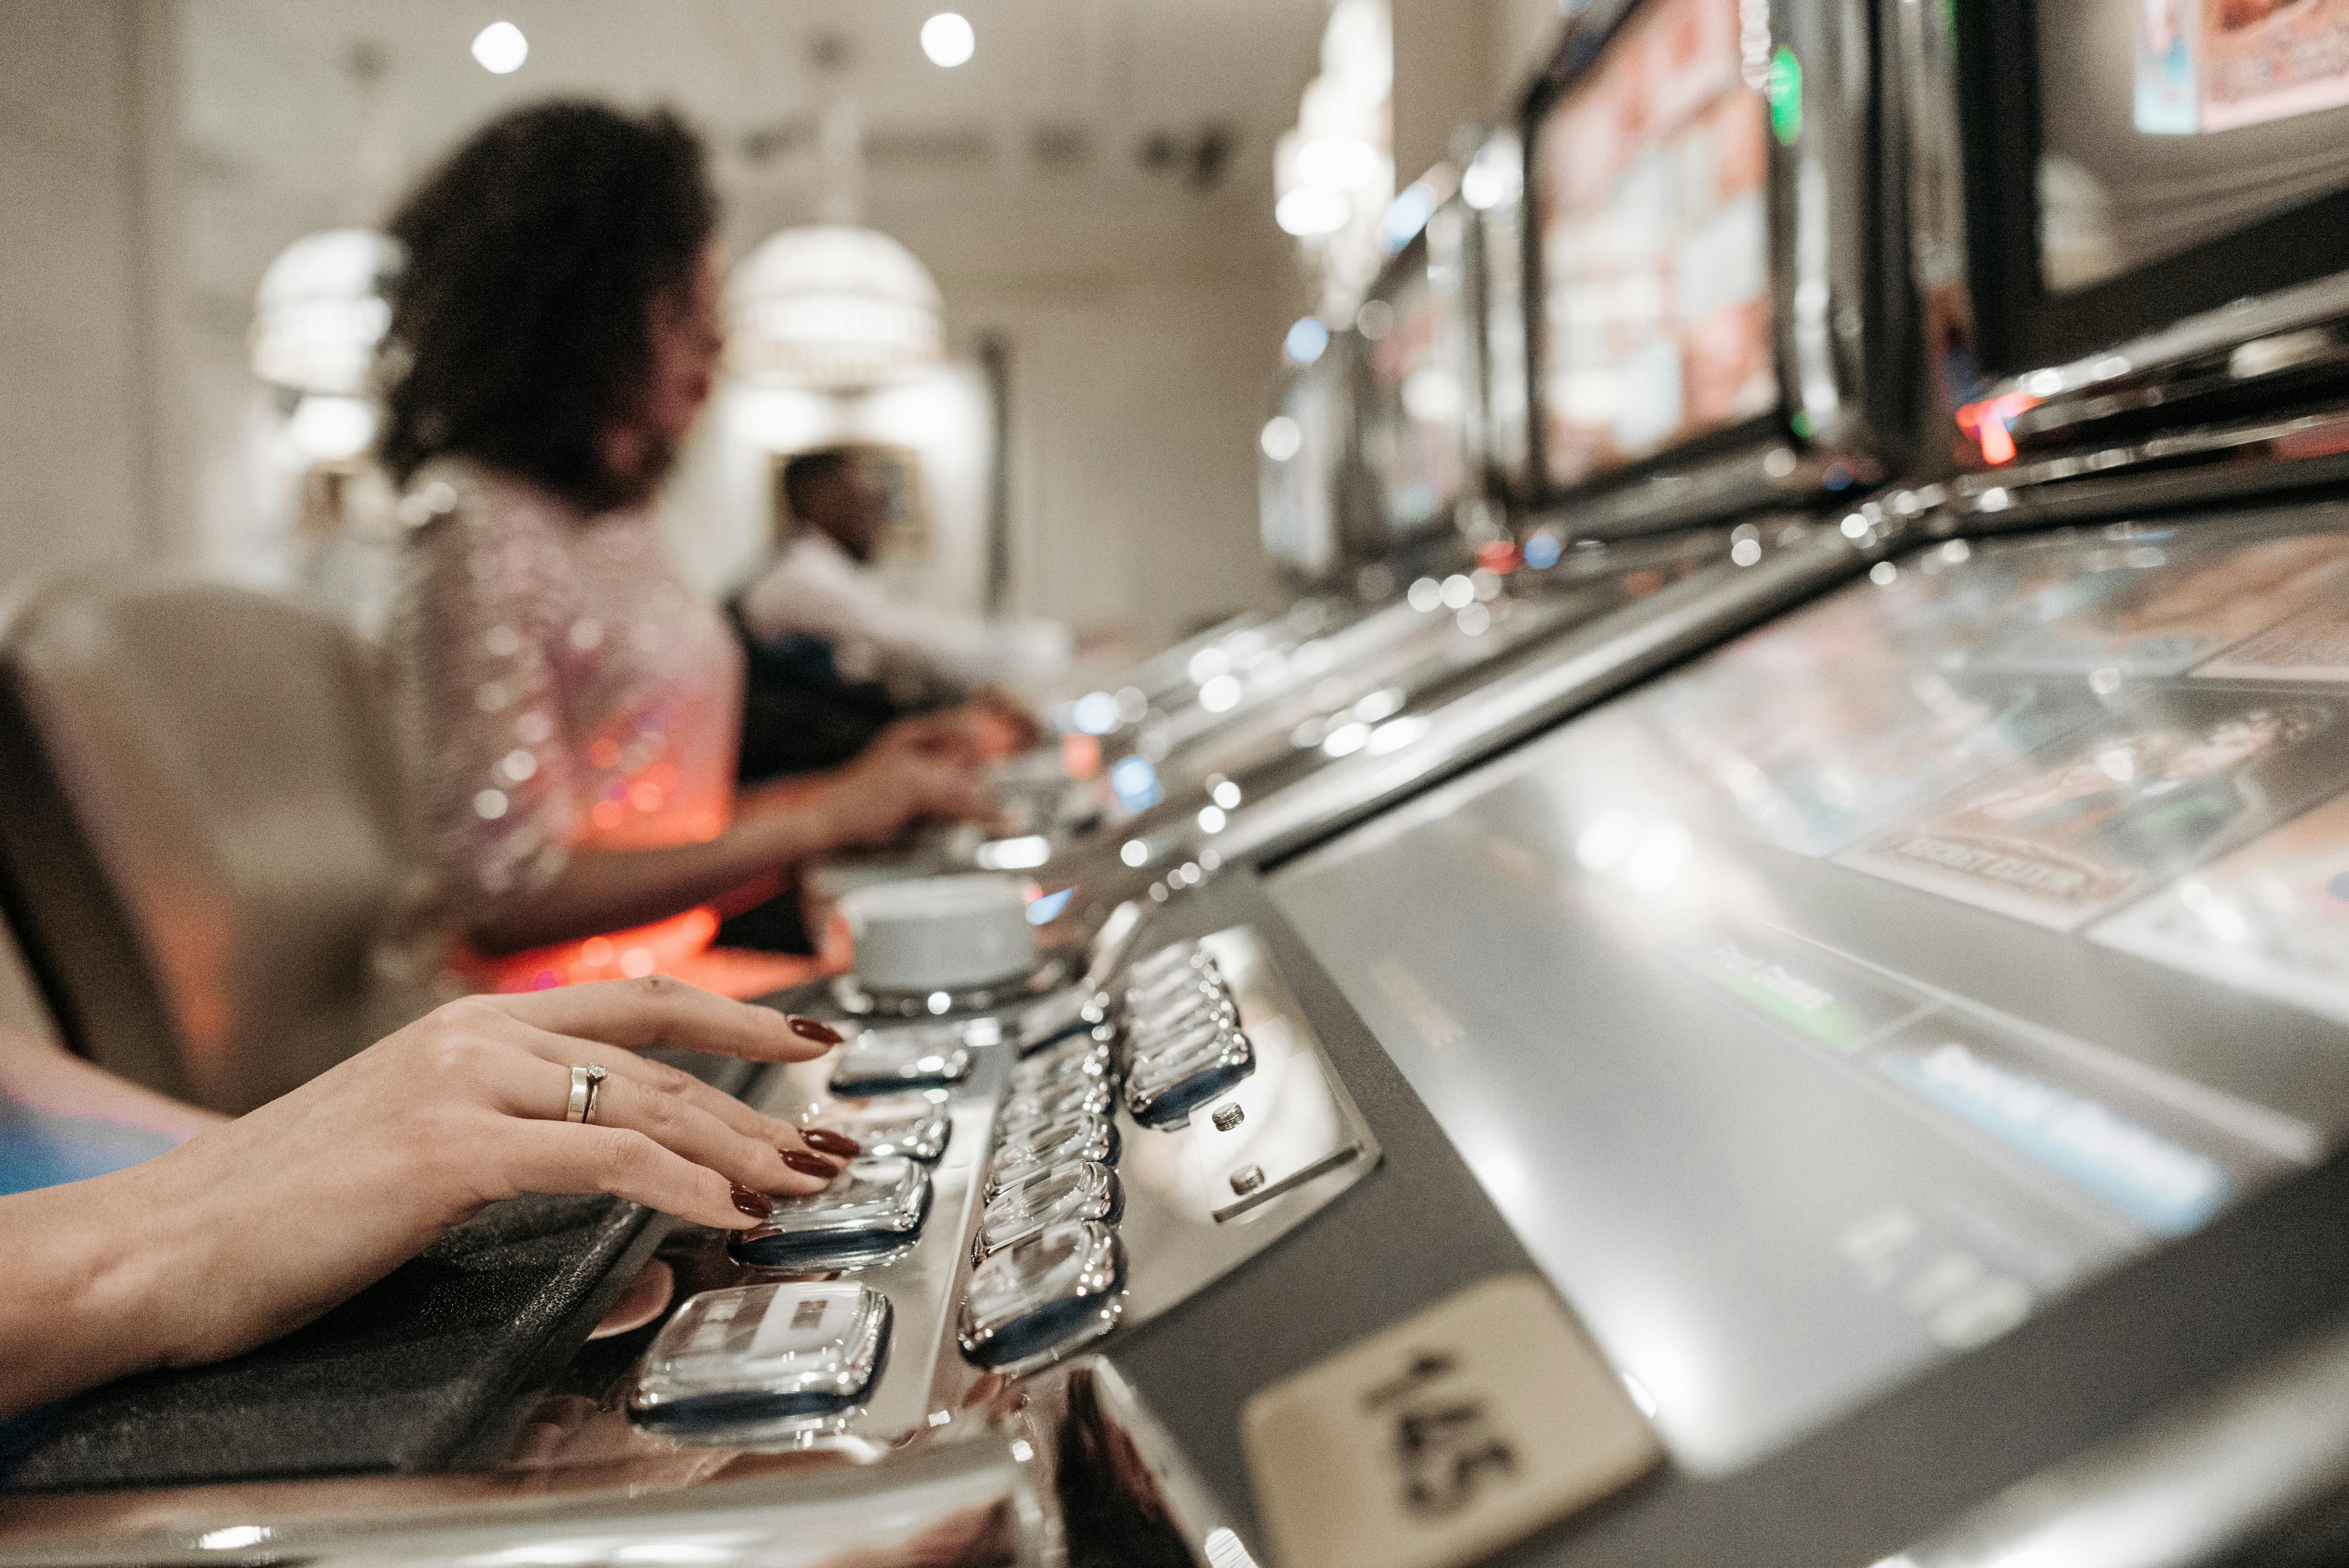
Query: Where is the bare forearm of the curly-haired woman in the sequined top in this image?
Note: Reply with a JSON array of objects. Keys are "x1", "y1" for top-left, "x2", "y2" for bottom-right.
[{"x1": 470, "y1": 810, "x2": 832, "y2": 953}]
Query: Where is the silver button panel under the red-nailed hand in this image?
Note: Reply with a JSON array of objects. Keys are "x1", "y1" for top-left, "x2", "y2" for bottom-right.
[{"x1": 653, "y1": 927, "x2": 1376, "y2": 1450}]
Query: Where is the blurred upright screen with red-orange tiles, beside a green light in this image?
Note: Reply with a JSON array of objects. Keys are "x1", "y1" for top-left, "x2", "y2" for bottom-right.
[{"x1": 1532, "y1": 0, "x2": 1778, "y2": 488}]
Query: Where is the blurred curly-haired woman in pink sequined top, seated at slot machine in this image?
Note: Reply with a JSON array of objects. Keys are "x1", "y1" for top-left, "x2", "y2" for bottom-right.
[{"x1": 383, "y1": 103, "x2": 987, "y2": 995}]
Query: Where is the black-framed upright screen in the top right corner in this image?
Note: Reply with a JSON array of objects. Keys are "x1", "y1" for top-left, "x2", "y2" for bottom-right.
[{"x1": 1961, "y1": 0, "x2": 2349, "y2": 371}]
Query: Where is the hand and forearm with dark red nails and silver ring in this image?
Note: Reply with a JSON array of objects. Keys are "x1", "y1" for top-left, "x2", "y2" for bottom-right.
[{"x1": 0, "y1": 976, "x2": 855, "y2": 1415}]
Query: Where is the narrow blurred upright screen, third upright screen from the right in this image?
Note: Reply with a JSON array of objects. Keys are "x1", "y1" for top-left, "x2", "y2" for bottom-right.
[{"x1": 1355, "y1": 232, "x2": 1466, "y2": 535}]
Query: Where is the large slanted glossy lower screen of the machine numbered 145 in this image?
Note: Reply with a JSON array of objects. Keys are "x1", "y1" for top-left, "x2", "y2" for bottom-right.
[{"x1": 1271, "y1": 523, "x2": 2349, "y2": 1472}]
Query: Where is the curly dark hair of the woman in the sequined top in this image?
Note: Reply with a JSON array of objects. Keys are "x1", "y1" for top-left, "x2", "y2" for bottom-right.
[{"x1": 381, "y1": 101, "x2": 716, "y2": 512}]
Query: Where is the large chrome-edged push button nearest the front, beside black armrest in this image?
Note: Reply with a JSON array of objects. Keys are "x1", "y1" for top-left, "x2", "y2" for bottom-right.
[{"x1": 627, "y1": 1284, "x2": 890, "y2": 1439}]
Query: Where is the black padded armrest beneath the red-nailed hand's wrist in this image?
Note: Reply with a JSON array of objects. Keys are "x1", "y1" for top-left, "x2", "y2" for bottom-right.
[{"x1": 5, "y1": 1052, "x2": 756, "y2": 1491}]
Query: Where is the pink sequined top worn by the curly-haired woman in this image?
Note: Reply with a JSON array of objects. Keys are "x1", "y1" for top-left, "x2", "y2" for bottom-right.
[{"x1": 385, "y1": 460, "x2": 742, "y2": 979}]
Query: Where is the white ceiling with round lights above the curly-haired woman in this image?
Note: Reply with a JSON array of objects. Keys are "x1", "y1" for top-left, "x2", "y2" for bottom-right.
[{"x1": 183, "y1": 0, "x2": 1325, "y2": 331}]
